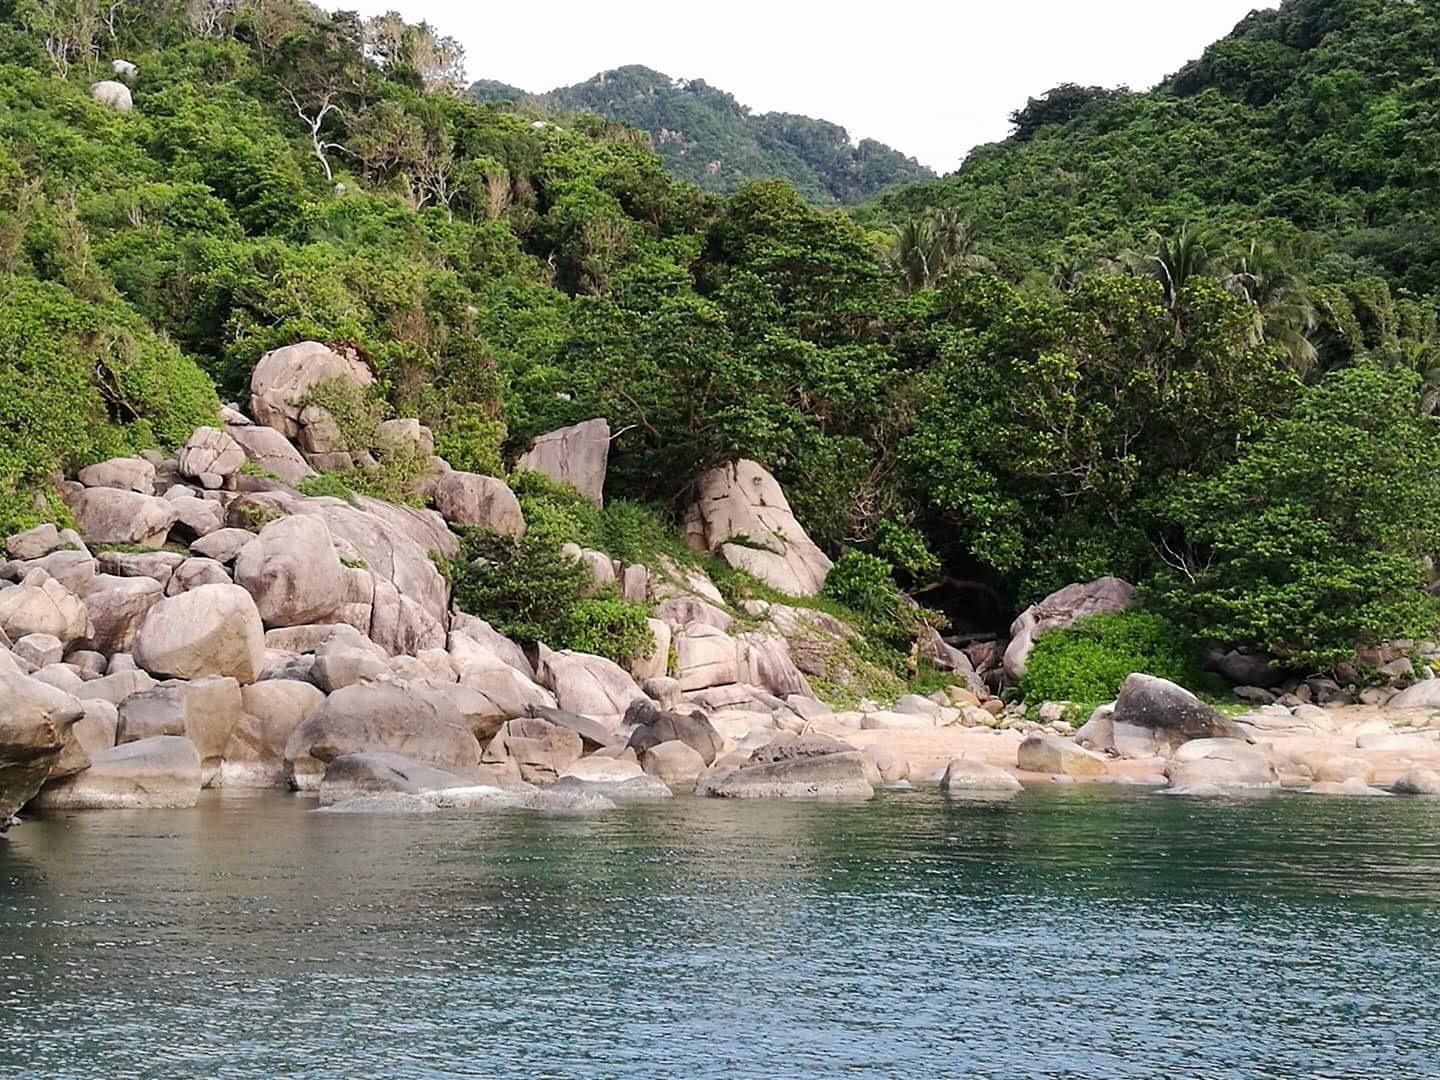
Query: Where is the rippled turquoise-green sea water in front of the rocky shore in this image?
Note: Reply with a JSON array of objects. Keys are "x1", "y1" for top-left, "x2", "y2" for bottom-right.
[{"x1": 0, "y1": 789, "x2": 1440, "y2": 1077}]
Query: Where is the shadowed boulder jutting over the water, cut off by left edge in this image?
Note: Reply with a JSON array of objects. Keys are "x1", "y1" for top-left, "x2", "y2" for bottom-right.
[{"x1": 0, "y1": 671, "x2": 85, "y2": 832}]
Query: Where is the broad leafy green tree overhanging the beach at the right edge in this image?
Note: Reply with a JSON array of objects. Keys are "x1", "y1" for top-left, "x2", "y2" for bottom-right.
[{"x1": 1152, "y1": 364, "x2": 1440, "y2": 665}]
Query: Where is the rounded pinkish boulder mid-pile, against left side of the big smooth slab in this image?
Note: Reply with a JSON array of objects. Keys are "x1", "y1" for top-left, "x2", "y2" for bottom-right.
[{"x1": 235, "y1": 514, "x2": 347, "y2": 626}]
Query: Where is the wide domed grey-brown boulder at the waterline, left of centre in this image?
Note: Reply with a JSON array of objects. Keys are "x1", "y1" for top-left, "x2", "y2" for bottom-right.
[{"x1": 285, "y1": 683, "x2": 480, "y2": 791}]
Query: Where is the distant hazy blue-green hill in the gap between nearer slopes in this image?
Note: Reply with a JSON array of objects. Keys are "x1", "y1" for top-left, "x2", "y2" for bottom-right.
[{"x1": 471, "y1": 65, "x2": 933, "y2": 206}]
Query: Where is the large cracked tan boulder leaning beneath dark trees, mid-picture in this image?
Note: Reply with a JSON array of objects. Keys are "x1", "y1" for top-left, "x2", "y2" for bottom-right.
[{"x1": 685, "y1": 461, "x2": 831, "y2": 596}]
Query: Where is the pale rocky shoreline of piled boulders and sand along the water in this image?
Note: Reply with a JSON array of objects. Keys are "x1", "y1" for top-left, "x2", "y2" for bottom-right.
[{"x1": 0, "y1": 343, "x2": 1440, "y2": 822}]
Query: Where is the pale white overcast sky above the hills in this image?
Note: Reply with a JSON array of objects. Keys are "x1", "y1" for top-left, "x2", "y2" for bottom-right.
[{"x1": 342, "y1": 0, "x2": 1274, "y2": 173}]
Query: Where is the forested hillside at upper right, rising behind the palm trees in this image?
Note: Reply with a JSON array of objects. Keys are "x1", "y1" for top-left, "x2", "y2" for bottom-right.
[{"x1": 871, "y1": 0, "x2": 1440, "y2": 292}]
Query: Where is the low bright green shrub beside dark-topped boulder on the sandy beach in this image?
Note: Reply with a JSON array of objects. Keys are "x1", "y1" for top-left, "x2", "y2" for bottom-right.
[{"x1": 1020, "y1": 611, "x2": 1212, "y2": 706}]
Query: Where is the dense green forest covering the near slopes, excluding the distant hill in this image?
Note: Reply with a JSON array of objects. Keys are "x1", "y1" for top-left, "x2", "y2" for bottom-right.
[{"x1": 0, "y1": 0, "x2": 1440, "y2": 676}]
